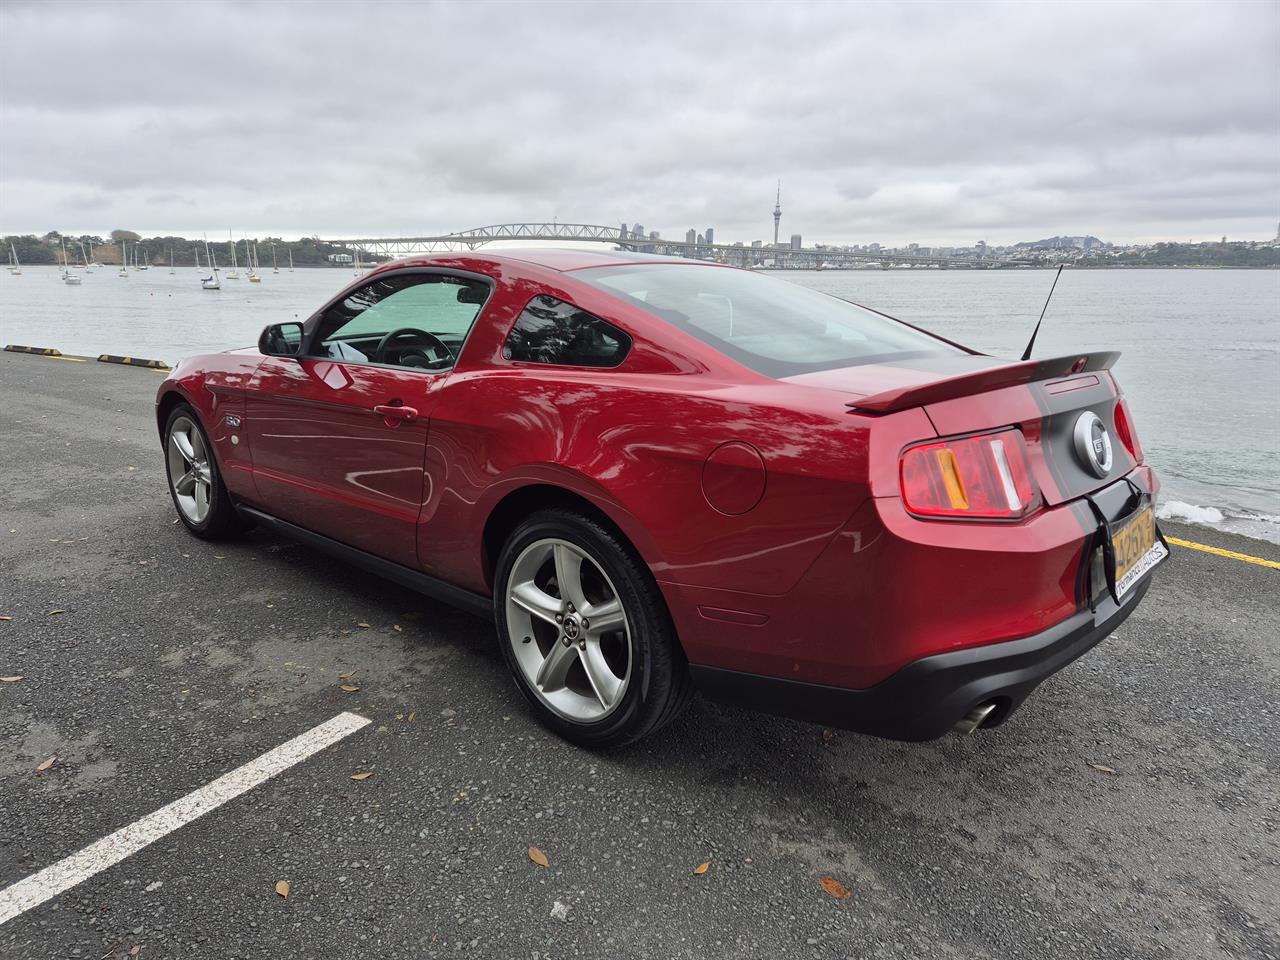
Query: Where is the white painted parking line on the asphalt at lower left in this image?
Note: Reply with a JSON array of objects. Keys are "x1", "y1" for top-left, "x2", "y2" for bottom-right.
[{"x1": 0, "y1": 713, "x2": 369, "y2": 925}]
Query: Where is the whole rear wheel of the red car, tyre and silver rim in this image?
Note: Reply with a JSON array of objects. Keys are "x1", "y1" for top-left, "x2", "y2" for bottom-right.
[{"x1": 494, "y1": 509, "x2": 692, "y2": 746}]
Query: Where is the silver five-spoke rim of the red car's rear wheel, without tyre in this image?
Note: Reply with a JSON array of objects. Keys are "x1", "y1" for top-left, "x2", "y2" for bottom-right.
[{"x1": 506, "y1": 538, "x2": 632, "y2": 723}]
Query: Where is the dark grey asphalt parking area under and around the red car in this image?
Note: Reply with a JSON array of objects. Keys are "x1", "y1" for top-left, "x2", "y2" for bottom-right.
[{"x1": 0, "y1": 353, "x2": 1280, "y2": 960}]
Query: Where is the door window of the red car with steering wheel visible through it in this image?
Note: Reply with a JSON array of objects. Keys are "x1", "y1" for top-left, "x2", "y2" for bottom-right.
[{"x1": 315, "y1": 274, "x2": 489, "y2": 370}]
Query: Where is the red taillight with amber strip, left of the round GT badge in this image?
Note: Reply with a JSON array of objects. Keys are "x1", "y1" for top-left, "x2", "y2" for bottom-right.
[{"x1": 902, "y1": 430, "x2": 1041, "y2": 520}]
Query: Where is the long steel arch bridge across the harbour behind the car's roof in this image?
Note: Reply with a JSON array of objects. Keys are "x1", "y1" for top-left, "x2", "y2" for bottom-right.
[{"x1": 325, "y1": 221, "x2": 997, "y2": 268}]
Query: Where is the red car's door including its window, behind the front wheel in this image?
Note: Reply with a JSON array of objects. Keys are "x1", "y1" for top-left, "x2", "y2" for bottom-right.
[{"x1": 243, "y1": 270, "x2": 492, "y2": 567}]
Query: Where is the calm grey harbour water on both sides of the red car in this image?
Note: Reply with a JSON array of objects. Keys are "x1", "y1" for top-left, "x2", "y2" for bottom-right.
[{"x1": 0, "y1": 266, "x2": 1280, "y2": 541}]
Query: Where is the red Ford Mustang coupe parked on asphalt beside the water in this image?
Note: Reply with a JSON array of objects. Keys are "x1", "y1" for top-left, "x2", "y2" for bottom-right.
[{"x1": 156, "y1": 250, "x2": 1167, "y2": 745}]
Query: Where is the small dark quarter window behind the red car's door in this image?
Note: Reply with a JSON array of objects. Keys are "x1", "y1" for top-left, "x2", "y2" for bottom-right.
[{"x1": 502, "y1": 296, "x2": 631, "y2": 366}]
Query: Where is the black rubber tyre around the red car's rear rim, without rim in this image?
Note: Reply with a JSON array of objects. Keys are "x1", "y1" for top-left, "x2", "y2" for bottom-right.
[{"x1": 494, "y1": 508, "x2": 692, "y2": 748}]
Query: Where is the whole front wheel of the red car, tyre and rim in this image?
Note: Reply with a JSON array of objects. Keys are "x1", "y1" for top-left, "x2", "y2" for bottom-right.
[{"x1": 164, "y1": 403, "x2": 244, "y2": 540}]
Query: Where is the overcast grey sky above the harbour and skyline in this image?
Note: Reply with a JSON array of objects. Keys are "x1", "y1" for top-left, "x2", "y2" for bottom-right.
[{"x1": 0, "y1": 0, "x2": 1280, "y2": 246}]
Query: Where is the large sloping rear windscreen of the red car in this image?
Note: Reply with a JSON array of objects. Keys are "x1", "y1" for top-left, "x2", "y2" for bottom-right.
[{"x1": 573, "y1": 264, "x2": 964, "y2": 376}]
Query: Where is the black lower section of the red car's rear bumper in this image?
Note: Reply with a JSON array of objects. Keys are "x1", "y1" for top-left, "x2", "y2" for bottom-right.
[{"x1": 690, "y1": 576, "x2": 1151, "y2": 741}]
